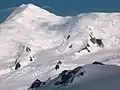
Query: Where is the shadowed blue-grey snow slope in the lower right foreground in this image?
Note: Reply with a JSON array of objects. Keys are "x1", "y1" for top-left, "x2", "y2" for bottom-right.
[{"x1": 36, "y1": 64, "x2": 120, "y2": 90}]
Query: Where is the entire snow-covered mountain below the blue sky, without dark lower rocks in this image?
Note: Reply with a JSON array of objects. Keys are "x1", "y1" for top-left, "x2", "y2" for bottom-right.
[{"x1": 0, "y1": 4, "x2": 120, "y2": 90}]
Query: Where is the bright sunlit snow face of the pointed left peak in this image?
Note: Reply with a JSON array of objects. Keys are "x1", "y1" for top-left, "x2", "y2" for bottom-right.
[{"x1": 0, "y1": 4, "x2": 67, "y2": 79}]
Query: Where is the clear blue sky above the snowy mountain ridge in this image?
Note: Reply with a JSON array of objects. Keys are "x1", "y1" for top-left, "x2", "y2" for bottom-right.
[{"x1": 0, "y1": 0, "x2": 120, "y2": 22}]
